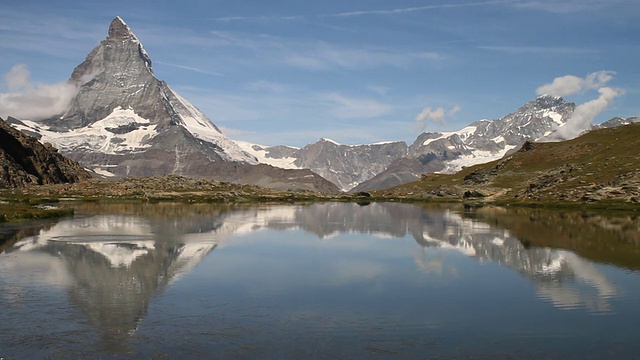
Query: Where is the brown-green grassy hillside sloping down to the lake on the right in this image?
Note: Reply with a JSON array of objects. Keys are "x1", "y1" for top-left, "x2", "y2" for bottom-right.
[{"x1": 376, "y1": 123, "x2": 640, "y2": 205}]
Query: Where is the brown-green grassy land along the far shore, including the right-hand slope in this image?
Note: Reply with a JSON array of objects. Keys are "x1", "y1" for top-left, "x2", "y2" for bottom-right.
[{"x1": 0, "y1": 124, "x2": 640, "y2": 215}]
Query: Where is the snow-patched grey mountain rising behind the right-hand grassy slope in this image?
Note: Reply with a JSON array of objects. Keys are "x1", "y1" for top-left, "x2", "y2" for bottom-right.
[{"x1": 352, "y1": 95, "x2": 575, "y2": 192}]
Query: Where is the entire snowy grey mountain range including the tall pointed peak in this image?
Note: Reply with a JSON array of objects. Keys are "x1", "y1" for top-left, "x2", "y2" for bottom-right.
[{"x1": 3, "y1": 17, "x2": 633, "y2": 193}]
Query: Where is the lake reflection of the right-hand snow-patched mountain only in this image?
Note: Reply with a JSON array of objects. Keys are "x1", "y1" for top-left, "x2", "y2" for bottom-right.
[{"x1": 414, "y1": 207, "x2": 618, "y2": 312}]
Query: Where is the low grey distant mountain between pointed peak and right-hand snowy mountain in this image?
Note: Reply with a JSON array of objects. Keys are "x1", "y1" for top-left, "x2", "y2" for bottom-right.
[{"x1": 239, "y1": 138, "x2": 408, "y2": 191}]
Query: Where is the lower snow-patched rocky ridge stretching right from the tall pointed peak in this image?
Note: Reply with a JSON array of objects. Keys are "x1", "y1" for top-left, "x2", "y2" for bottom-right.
[{"x1": 240, "y1": 95, "x2": 575, "y2": 192}]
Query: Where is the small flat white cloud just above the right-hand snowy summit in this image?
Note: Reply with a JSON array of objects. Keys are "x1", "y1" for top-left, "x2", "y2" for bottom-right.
[{"x1": 536, "y1": 70, "x2": 615, "y2": 96}]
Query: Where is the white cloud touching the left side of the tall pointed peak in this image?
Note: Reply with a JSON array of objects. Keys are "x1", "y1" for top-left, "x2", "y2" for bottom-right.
[{"x1": 0, "y1": 64, "x2": 78, "y2": 120}]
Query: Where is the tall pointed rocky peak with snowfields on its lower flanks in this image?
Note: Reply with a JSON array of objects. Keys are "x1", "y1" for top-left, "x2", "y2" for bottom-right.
[{"x1": 12, "y1": 17, "x2": 339, "y2": 192}]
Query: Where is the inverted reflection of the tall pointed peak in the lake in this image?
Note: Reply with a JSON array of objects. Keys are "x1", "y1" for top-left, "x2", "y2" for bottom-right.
[{"x1": 3, "y1": 215, "x2": 216, "y2": 351}]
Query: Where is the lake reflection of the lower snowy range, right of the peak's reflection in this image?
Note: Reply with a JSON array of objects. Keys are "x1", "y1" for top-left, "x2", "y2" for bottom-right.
[{"x1": 205, "y1": 203, "x2": 617, "y2": 311}]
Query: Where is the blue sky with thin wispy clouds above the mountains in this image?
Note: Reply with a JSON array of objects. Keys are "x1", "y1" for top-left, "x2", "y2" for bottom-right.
[{"x1": 0, "y1": 0, "x2": 640, "y2": 146}]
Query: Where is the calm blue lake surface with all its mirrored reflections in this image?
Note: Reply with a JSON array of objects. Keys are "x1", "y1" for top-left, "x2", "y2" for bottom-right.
[{"x1": 0, "y1": 203, "x2": 640, "y2": 359}]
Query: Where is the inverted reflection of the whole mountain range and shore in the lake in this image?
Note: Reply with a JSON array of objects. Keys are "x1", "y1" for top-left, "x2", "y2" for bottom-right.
[{"x1": 0, "y1": 203, "x2": 640, "y2": 356}]
